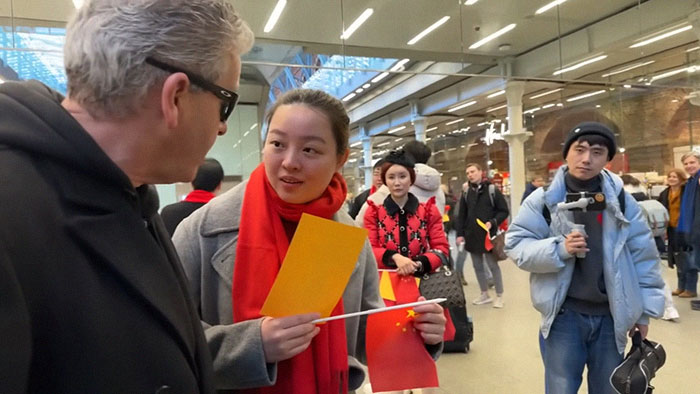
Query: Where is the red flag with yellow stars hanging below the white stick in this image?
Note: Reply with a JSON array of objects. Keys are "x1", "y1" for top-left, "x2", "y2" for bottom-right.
[{"x1": 366, "y1": 309, "x2": 440, "y2": 392}]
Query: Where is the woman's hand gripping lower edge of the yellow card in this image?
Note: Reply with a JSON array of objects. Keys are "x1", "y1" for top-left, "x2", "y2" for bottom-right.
[{"x1": 260, "y1": 313, "x2": 321, "y2": 363}]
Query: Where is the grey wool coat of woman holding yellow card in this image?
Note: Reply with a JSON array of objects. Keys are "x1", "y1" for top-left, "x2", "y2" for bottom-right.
[{"x1": 173, "y1": 182, "x2": 424, "y2": 390}]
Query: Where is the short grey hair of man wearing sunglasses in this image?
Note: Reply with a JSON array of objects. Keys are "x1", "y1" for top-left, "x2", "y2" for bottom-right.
[{"x1": 64, "y1": 0, "x2": 254, "y2": 118}]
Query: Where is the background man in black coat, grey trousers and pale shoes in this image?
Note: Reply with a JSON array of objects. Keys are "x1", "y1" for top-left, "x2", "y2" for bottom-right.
[{"x1": 455, "y1": 163, "x2": 509, "y2": 308}]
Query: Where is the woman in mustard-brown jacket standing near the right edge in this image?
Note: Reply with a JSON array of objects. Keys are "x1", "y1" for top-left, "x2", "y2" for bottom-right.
[{"x1": 659, "y1": 168, "x2": 687, "y2": 297}]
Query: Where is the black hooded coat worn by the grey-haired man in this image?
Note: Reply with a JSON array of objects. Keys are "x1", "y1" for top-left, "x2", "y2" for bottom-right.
[{"x1": 0, "y1": 82, "x2": 214, "y2": 394}]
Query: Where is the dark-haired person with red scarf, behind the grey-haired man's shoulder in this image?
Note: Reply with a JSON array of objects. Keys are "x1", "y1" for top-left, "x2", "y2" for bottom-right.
[{"x1": 160, "y1": 158, "x2": 224, "y2": 237}]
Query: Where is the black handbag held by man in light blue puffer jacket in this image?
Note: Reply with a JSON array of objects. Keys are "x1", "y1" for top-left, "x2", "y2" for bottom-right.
[{"x1": 610, "y1": 331, "x2": 666, "y2": 394}]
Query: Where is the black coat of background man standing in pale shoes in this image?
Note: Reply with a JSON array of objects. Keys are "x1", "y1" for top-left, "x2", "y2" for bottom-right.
[{"x1": 454, "y1": 181, "x2": 509, "y2": 253}]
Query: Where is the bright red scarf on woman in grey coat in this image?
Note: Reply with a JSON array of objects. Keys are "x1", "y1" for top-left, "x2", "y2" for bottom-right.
[{"x1": 232, "y1": 164, "x2": 348, "y2": 394}]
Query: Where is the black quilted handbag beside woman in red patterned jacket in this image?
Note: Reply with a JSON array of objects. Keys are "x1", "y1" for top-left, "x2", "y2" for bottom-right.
[{"x1": 418, "y1": 250, "x2": 467, "y2": 308}]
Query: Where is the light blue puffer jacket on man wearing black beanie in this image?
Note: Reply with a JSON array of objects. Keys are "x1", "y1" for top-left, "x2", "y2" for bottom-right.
[{"x1": 506, "y1": 166, "x2": 664, "y2": 353}]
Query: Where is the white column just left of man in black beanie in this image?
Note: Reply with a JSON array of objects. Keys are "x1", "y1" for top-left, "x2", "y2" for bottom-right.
[{"x1": 503, "y1": 81, "x2": 532, "y2": 216}]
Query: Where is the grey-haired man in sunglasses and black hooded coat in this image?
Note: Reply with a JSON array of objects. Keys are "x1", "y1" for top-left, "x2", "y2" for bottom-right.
[{"x1": 0, "y1": 0, "x2": 253, "y2": 394}]
